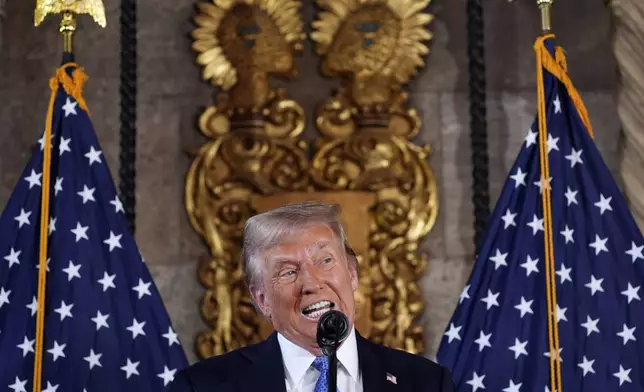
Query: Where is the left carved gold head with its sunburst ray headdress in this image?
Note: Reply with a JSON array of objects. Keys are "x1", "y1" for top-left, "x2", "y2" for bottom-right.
[{"x1": 192, "y1": 0, "x2": 304, "y2": 94}]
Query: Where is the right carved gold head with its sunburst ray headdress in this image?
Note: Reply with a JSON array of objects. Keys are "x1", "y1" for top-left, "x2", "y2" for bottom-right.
[{"x1": 311, "y1": 0, "x2": 431, "y2": 106}]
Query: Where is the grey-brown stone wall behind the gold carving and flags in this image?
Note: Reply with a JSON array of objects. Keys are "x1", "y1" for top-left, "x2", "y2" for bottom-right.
[{"x1": 0, "y1": 0, "x2": 620, "y2": 360}]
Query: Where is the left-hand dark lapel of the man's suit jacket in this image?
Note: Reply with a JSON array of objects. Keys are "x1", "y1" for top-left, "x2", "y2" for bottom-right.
[{"x1": 237, "y1": 332, "x2": 286, "y2": 392}]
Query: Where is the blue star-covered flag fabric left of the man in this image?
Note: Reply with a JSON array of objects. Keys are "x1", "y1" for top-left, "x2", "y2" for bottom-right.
[{"x1": 0, "y1": 62, "x2": 187, "y2": 392}]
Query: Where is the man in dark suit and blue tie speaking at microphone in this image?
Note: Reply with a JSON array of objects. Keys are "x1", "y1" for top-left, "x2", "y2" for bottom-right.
[{"x1": 170, "y1": 203, "x2": 454, "y2": 392}]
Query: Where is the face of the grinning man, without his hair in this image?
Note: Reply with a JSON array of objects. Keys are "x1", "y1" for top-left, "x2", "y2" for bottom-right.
[{"x1": 251, "y1": 225, "x2": 358, "y2": 355}]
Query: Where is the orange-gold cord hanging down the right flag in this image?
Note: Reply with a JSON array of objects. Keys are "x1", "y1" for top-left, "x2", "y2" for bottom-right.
[{"x1": 535, "y1": 34, "x2": 562, "y2": 392}]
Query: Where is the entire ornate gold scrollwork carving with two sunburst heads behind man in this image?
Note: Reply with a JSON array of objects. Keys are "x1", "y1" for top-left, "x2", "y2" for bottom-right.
[{"x1": 186, "y1": 0, "x2": 438, "y2": 357}]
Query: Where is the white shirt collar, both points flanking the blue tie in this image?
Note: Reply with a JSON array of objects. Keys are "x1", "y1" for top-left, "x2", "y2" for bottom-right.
[{"x1": 277, "y1": 328, "x2": 359, "y2": 385}]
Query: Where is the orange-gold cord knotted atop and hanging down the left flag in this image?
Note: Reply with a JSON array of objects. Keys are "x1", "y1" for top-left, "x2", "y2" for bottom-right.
[{"x1": 32, "y1": 63, "x2": 87, "y2": 392}]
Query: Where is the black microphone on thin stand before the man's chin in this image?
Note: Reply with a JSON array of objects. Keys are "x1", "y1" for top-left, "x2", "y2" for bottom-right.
[{"x1": 317, "y1": 310, "x2": 349, "y2": 392}]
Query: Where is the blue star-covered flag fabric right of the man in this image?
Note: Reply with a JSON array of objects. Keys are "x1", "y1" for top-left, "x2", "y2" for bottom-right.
[{"x1": 437, "y1": 39, "x2": 644, "y2": 392}]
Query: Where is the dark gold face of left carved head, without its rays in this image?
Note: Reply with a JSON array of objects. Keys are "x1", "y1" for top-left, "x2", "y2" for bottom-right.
[{"x1": 217, "y1": 4, "x2": 293, "y2": 77}]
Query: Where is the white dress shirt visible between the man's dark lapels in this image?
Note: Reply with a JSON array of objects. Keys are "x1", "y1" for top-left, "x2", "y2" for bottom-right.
[{"x1": 277, "y1": 328, "x2": 362, "y2": 392}]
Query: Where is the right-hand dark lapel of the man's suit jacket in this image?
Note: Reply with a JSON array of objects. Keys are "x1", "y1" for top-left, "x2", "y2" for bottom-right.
[{"x1": 356, "y1": 331, "x2": 406, "y2": 392}]
